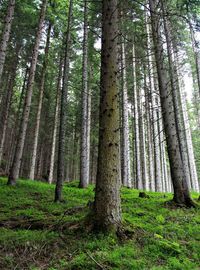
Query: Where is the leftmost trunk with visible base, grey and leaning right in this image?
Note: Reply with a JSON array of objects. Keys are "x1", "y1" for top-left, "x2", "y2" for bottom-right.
[{"x1": 8, "y1": 0, "x2": 48, "y2": 185}]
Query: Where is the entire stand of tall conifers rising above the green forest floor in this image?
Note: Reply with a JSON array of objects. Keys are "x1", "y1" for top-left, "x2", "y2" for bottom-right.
[{"x1": 0, "y1": 0, "x2": 200, "y2": 230}]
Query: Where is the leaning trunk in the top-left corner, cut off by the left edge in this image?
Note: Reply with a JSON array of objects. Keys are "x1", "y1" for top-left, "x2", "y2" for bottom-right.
[{"x1": 0, "y1": 0, "x2": 15, "y2": 88}]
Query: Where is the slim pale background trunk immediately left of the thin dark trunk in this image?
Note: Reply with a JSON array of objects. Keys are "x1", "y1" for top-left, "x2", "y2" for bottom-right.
[{"x1": 48, "y1": 59, "x2": 63, "y2": 184}]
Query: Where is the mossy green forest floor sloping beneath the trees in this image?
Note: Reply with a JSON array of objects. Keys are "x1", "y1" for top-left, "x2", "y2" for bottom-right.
[{"x1": 0, "y1": 178, "x2": 200, "y2": 270}]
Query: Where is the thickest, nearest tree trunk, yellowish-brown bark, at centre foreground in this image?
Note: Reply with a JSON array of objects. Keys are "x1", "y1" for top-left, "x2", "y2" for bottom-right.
[{"x1": 94, "y1": 0, "x2": 121, "y2": 231}]
